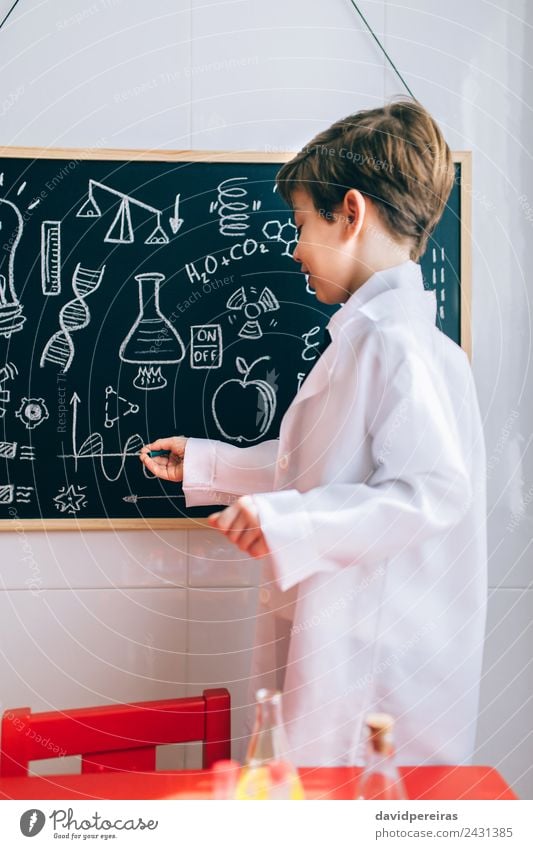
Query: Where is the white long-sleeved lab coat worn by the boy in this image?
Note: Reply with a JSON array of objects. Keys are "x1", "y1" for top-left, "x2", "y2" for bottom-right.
[{"x1": 184, "y1": 262, "x2": 487, "y2": 765}]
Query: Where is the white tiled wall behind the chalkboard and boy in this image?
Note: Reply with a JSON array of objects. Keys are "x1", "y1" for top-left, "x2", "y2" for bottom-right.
[{"x1": 0, "y1": 0, "x2": 533, "y2": 798}]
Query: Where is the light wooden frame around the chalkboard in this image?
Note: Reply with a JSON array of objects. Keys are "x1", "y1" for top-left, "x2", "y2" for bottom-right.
[{"x1": 0, "y1": 147, "x2": 472, "y2": 534}]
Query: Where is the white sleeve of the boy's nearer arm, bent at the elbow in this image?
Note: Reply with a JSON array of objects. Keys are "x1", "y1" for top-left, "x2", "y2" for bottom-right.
[{"x1": 254, "y1": 348, "x2": 472, "y2": 590}]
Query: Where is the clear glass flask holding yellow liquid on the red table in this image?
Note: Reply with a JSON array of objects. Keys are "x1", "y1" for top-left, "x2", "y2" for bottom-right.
[{"x1": 235, "y1": 689, "x2": 305, "y2": 801}]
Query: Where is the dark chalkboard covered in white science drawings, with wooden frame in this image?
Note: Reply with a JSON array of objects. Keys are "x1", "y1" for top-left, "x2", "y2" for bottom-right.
[{"x1": 0, "y1": 149, "x2": 469, "y2": 530}]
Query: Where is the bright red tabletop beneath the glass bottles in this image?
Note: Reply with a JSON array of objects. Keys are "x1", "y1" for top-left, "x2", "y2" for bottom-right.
[{"x1": 0, "y1": 766, "x2": 517, "y2": 800}]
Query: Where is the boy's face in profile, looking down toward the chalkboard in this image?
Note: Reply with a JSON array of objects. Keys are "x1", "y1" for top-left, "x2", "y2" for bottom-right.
[{"x1": 292, "y1": 189, "x2": 354, "y2": 304}]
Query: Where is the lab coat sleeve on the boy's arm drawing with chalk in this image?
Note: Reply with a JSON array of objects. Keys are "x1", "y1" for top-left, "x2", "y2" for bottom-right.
[{"x1": 183, "y1": 438, "x2": 278, "y2": 507}]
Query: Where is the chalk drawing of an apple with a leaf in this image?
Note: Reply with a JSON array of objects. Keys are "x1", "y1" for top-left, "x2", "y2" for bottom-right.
[{"x1": 212, "y1": 357, "x2": 278, "y2": 442}]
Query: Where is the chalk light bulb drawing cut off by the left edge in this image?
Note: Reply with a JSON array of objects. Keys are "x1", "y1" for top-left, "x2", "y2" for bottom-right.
[{"x1": 0, "y1": 199, "x2": 26, "y2": 339}]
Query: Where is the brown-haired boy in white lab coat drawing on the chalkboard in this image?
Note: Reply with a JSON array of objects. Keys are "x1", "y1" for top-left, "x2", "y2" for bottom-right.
[{"x1": 141, "y1": 101, "x2": 486, "y2": 766}]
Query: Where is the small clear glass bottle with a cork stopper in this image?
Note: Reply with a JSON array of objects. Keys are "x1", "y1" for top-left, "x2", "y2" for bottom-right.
[{"x1": 356, "y1": 713, "x2": 407, "y2": 801}]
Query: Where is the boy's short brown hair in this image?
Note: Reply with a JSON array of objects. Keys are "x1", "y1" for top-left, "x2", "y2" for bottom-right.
[{"x1": 276, "y1": 100, "x2": 454, "y2": 260}]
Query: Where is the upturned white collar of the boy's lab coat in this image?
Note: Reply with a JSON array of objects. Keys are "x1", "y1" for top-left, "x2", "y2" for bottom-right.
[{"x1": 328, "y1": 260, "x2": 437, "y2": 339}]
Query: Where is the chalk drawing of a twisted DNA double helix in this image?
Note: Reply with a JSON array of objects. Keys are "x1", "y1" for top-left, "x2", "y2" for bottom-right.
[{"x1": 39, "y1": 263, "x2": 105, "y2": 374}]
